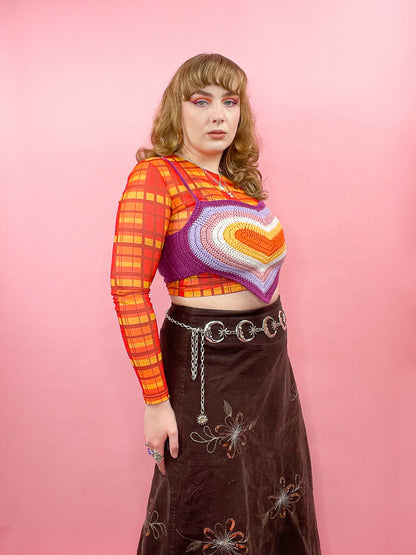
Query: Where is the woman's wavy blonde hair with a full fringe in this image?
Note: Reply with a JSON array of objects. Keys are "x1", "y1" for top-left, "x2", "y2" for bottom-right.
[{"x1": 136, "y1": 54, "x2": 266, "y2": 200}]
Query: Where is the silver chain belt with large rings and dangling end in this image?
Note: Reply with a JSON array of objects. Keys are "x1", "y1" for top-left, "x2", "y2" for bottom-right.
[{"x1": 166, "y1": 310, "x2": 287, "y2": 426}]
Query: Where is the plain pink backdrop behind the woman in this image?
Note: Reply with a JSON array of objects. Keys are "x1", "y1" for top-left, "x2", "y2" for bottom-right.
[{"x1": 0, "y1": 0, "x2": 416, "y2": 555}]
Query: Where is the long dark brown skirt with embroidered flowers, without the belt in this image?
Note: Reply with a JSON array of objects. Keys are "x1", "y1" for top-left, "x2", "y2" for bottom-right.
[{"x1": 137, "y1": 299, "x2": 321, "y2": 555}]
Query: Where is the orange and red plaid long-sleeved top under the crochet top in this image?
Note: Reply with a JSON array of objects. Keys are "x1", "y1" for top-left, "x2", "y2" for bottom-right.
[{"x1": 111, "y1": 156, "x2": 257, "y2": 404}]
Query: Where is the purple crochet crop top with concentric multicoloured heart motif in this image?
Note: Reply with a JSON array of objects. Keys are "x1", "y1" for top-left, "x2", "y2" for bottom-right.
[{"x1": 159, "y1": 160, "x2": 286, "y2": 302}]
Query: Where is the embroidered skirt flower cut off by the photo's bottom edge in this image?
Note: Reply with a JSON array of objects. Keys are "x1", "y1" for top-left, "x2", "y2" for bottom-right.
[{"x1": 186, "y1": 518, "x2": 248, "y2": 555}]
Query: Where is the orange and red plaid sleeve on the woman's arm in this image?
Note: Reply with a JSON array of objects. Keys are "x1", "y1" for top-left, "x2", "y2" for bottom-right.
[{"x1": 111, "y1": 160, "x2": 171, "y2": 404}]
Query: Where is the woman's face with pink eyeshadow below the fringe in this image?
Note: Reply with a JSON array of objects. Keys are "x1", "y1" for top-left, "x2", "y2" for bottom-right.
[{"x1": 181, "y1": 85, "x2": 240, "y2": 162}]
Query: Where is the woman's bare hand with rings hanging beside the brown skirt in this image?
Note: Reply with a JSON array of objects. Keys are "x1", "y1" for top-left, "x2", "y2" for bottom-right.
[{"x1": 144, "y1": 399, "x2": 179, "y2": 475}]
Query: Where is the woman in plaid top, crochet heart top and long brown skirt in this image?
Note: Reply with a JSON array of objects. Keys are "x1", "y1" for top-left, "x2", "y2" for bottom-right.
[{"x1": 112, "y1": 54, "x2": 320, "y2": 555}]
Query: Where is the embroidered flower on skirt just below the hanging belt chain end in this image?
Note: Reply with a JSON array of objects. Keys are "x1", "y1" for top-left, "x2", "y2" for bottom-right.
[{"x1": 191, "y1": 401, "x2": 256, "y2": 459}]
